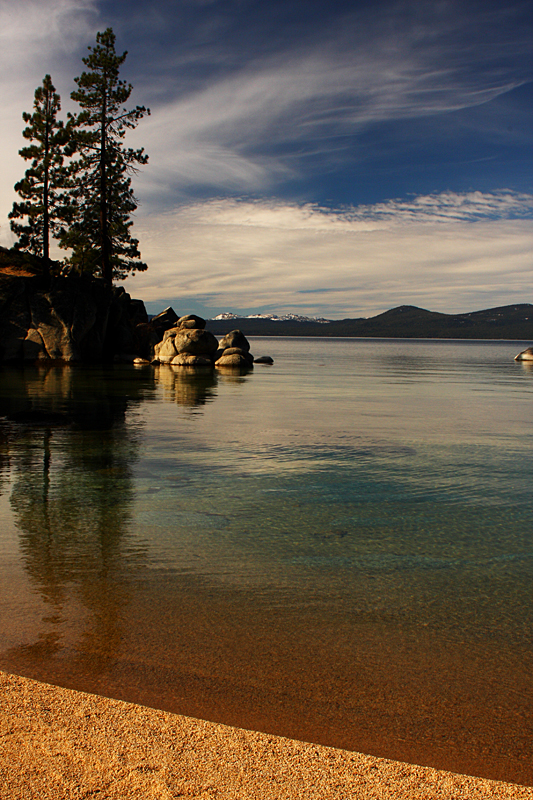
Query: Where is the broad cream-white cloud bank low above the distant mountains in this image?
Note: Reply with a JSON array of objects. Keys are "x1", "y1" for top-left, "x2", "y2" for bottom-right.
[{"x1": 128, "y1": 192, "x2": 533, "y2": 318}]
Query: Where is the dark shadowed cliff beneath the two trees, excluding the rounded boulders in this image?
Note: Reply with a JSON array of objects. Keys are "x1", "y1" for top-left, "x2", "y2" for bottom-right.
[{"x1": 0, "y1": 271, "x2": 148, "y2": 362}]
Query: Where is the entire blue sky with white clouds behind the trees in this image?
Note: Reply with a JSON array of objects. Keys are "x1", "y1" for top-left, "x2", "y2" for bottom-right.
[{"x1": 0, "y1": 0, "x2": 533, "y2": 319}]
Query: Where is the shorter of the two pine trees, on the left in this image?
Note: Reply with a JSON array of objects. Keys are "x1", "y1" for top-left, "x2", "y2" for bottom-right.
[{"x1": 9, "y1": 75, "x2": 71, "y2": 271}]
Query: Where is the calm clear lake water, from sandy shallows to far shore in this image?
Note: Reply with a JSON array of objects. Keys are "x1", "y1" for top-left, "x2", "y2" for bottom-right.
[{"x1": 0, "y1": 338, "x2": 533, "y2": 784}]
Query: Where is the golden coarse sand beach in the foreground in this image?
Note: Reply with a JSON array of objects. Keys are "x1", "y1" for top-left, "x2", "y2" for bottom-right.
[{"x1": 0, "y1": 672, "x2": 533, "y2": 800}]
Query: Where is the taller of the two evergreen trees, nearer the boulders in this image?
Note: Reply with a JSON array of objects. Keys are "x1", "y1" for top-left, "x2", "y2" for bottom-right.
[{"x1": 61, "y1": 28, "x2": 150, "y2": 285}]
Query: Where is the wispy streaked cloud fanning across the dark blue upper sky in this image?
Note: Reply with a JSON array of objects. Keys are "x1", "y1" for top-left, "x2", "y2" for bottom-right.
[{"x1": 130, "y1": 3, "x2": 531, "y2": 202}]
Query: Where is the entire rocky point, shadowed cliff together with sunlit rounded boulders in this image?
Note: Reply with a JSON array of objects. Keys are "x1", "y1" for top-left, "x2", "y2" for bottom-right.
[{"x1": 0, "y1": 255, "x2": 271, "y2": 368}]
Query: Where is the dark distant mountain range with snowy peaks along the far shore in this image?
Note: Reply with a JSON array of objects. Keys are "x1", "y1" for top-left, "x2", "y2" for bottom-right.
[{"x1": 208, "y1": 303, "x2": 533, "y2": 341}]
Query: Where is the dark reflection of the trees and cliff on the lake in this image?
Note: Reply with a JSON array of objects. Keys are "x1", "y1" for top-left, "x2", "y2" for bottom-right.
[{"x1": 0, "y1": 366, "x2": 154, "y2": 676}]
